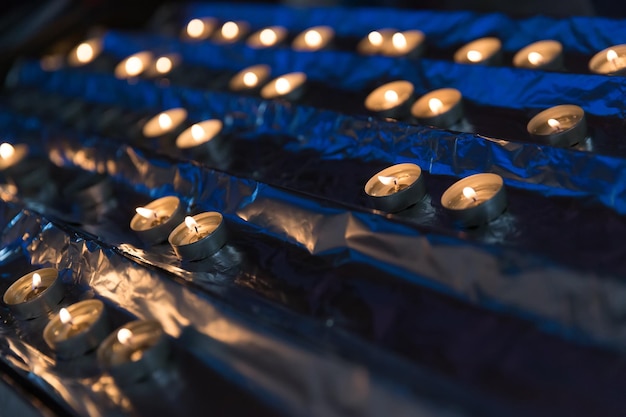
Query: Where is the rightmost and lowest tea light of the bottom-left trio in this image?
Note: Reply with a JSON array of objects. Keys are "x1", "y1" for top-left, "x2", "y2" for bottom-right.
[{"x1": 97, "y1": 320, "x2": 170, "y2": 385}]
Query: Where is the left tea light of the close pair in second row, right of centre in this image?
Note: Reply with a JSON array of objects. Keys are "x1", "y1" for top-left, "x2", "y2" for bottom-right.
[{"x1": 365, "y1": 80, "x2": 413, "y2": 119}]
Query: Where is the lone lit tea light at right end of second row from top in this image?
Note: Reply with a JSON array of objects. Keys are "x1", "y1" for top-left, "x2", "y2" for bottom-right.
[{"x1": 526, "y1": 104, "x2": 587, "y2": 147}]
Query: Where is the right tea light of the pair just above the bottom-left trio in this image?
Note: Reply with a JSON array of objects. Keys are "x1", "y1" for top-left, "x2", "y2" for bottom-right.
[{"x1": 168, "y1": 211, "x2": 226, "y2": 261}]
